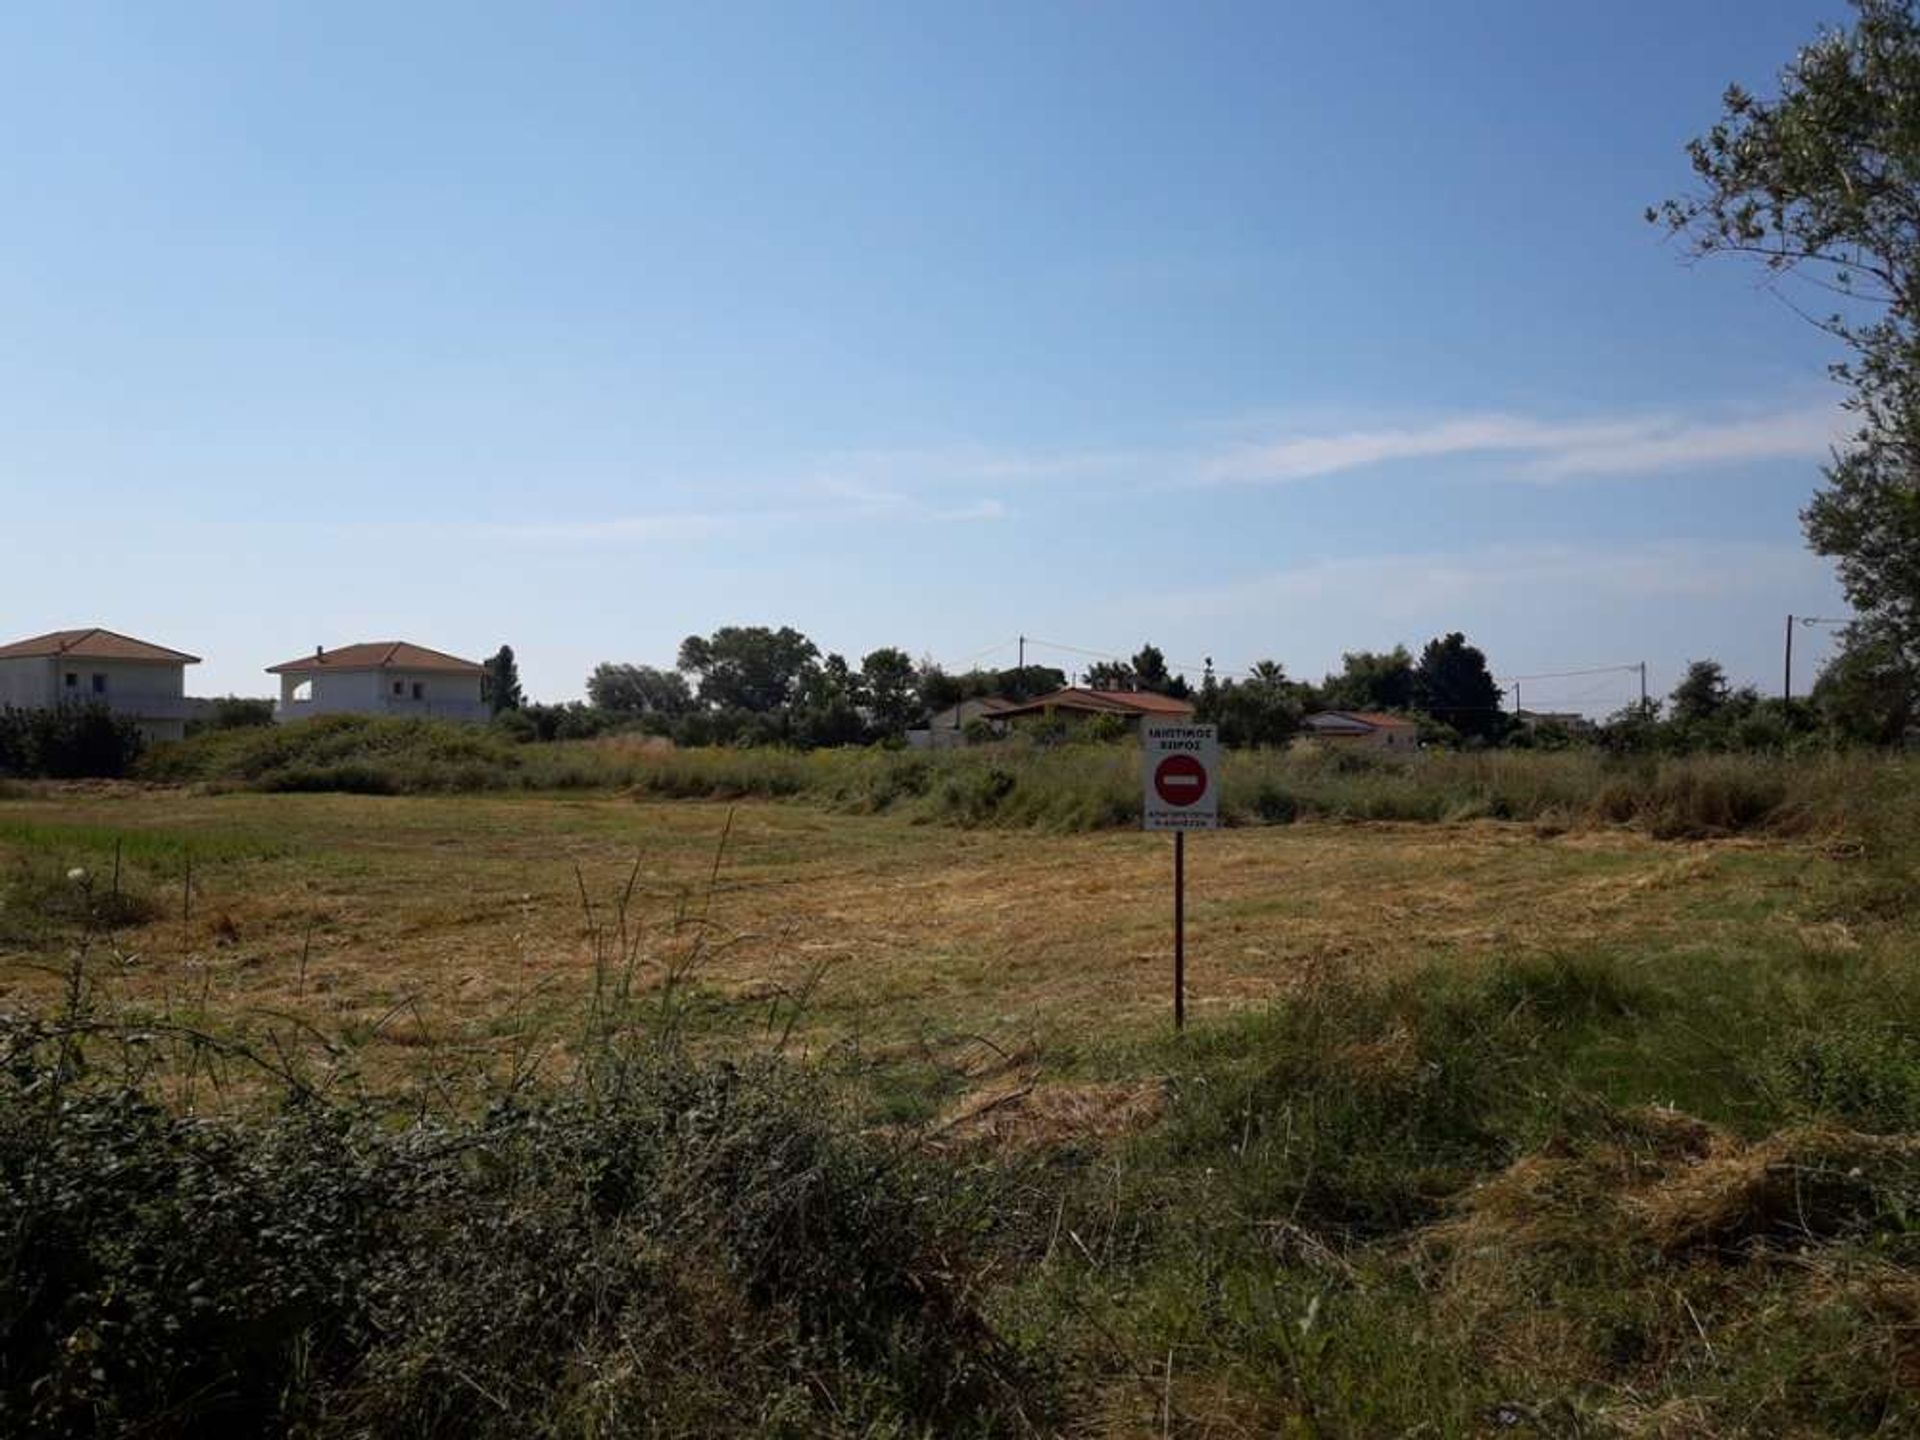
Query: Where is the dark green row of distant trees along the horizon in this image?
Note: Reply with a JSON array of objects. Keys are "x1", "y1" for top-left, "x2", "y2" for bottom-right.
[{"x1": 468, "y1": 626, "x2": 1914, "y2": 751}]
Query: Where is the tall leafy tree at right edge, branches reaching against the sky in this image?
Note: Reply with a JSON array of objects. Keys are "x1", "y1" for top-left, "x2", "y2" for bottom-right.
[{"x1": 1647, "y1": 0, "x2": 1920, "y2": 664}]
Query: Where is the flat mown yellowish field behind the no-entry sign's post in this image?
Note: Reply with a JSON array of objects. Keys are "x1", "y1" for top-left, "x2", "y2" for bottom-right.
[{"x1": 0, "y1": 787, "x2": 1853, "y2": 1090}]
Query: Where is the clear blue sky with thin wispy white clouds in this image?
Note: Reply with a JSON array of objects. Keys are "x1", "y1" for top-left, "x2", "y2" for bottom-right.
[{"x1": 0, "y1": 0, "x2": 1843, "y2": 708}]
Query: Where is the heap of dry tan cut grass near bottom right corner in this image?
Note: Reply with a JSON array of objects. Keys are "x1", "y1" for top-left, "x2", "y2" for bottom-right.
[{"x1": 1417, "y1": 1110, "x2": 1920, "y2": 1413}]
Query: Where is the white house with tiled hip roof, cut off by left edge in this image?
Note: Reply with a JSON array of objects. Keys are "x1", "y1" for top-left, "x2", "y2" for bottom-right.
[{"x1": 0, "y1": 626, "x2": 200, "y2": 739}]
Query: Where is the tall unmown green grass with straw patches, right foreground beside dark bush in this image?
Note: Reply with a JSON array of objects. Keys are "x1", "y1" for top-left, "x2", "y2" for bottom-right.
[{"x1": 1000, "y1": 954, "x2": 1920, "y2": 1436}]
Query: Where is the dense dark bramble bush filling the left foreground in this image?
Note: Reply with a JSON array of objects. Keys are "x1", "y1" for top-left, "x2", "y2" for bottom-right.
[{"x1": 0, "y1": 1016, "x2": 1044, "y2": 1436}]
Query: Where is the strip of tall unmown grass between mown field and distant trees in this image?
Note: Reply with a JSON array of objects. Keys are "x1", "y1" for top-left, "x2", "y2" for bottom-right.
[{"x1": 142, "y1": 716, "x2": 1920, "y2": 852}]
